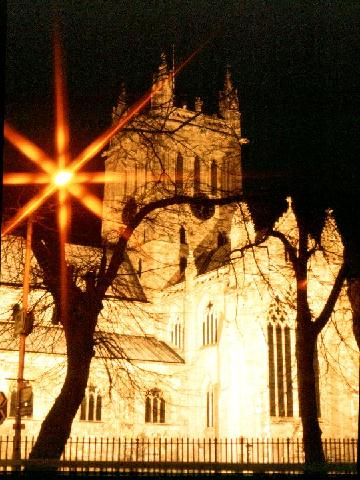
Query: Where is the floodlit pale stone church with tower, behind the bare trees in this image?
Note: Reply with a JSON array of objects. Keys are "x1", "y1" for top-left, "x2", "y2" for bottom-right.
[{"x1": 0, "y1": 57, "x2": 358, "y2": 438}]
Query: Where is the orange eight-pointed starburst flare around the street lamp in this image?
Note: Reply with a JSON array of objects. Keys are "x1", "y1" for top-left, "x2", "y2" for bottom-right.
[{"x1": 2, "y1": 30, "x2": 207, "y2": 324}]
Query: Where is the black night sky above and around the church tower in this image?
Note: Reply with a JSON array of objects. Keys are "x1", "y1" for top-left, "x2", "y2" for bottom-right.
[{"x1": 4, "y1": 0, "x2": 360, "y2": 244}]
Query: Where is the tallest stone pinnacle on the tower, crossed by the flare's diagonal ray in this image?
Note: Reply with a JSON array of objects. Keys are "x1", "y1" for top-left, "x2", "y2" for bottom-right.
[{"x1": 151, "y1": 52, "x2": 174, "y2": 108}]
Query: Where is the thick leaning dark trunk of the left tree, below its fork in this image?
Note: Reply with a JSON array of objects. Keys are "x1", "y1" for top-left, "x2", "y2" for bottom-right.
[{"x1": 27, "y1": 312, "x2": 97, "y2": 470}]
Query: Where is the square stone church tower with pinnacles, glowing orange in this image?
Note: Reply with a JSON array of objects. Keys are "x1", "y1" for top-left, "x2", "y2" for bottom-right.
[{"x1": 102, "y1": 55, "x2": 246, "y2": 294}]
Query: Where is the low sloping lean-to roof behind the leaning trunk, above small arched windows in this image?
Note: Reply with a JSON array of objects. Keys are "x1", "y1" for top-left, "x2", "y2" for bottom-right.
[{"x1": 0, "y1": 322, "x2": 184, "y2": 363}]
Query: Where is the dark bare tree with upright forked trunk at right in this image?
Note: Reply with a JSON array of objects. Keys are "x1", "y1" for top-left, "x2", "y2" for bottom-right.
[{"x1": 245, "y1": 195, "x2": 352, "y2": 465}]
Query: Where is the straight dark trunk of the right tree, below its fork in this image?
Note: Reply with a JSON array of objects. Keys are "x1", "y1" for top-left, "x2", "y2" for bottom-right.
[{"x1": 296, "y1": 322, "x2": 325, "y2": 467}]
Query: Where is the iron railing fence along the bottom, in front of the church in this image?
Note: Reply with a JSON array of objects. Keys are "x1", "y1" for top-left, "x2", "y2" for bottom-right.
[{"x1": 0, "y1": 436, "x2": 357, "y2": 471}]
